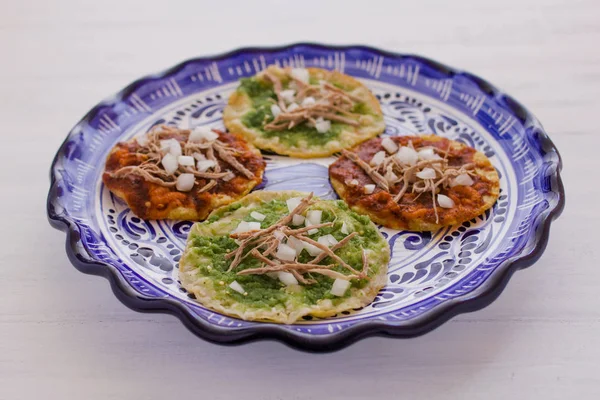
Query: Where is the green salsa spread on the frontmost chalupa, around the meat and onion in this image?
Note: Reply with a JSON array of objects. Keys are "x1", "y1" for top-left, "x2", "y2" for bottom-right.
[{"x1": 181, "y1": 200, "x2": 387, "y2": 309}]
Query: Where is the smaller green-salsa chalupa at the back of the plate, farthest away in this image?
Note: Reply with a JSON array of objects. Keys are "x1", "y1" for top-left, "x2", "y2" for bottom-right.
[{"x1": 223, "y1": 65, "x2": 385, "y2": 158}]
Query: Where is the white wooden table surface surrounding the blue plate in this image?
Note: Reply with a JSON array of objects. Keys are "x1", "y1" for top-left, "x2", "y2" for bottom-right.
[{"x1": 0, "y1": 0, "x2": 600, "y2": 400}]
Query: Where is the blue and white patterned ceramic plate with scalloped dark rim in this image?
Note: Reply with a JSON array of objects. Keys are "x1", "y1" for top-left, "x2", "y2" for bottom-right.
[{"x1": 48, "y1": 44, "x2": 564, "y2": 351}]
